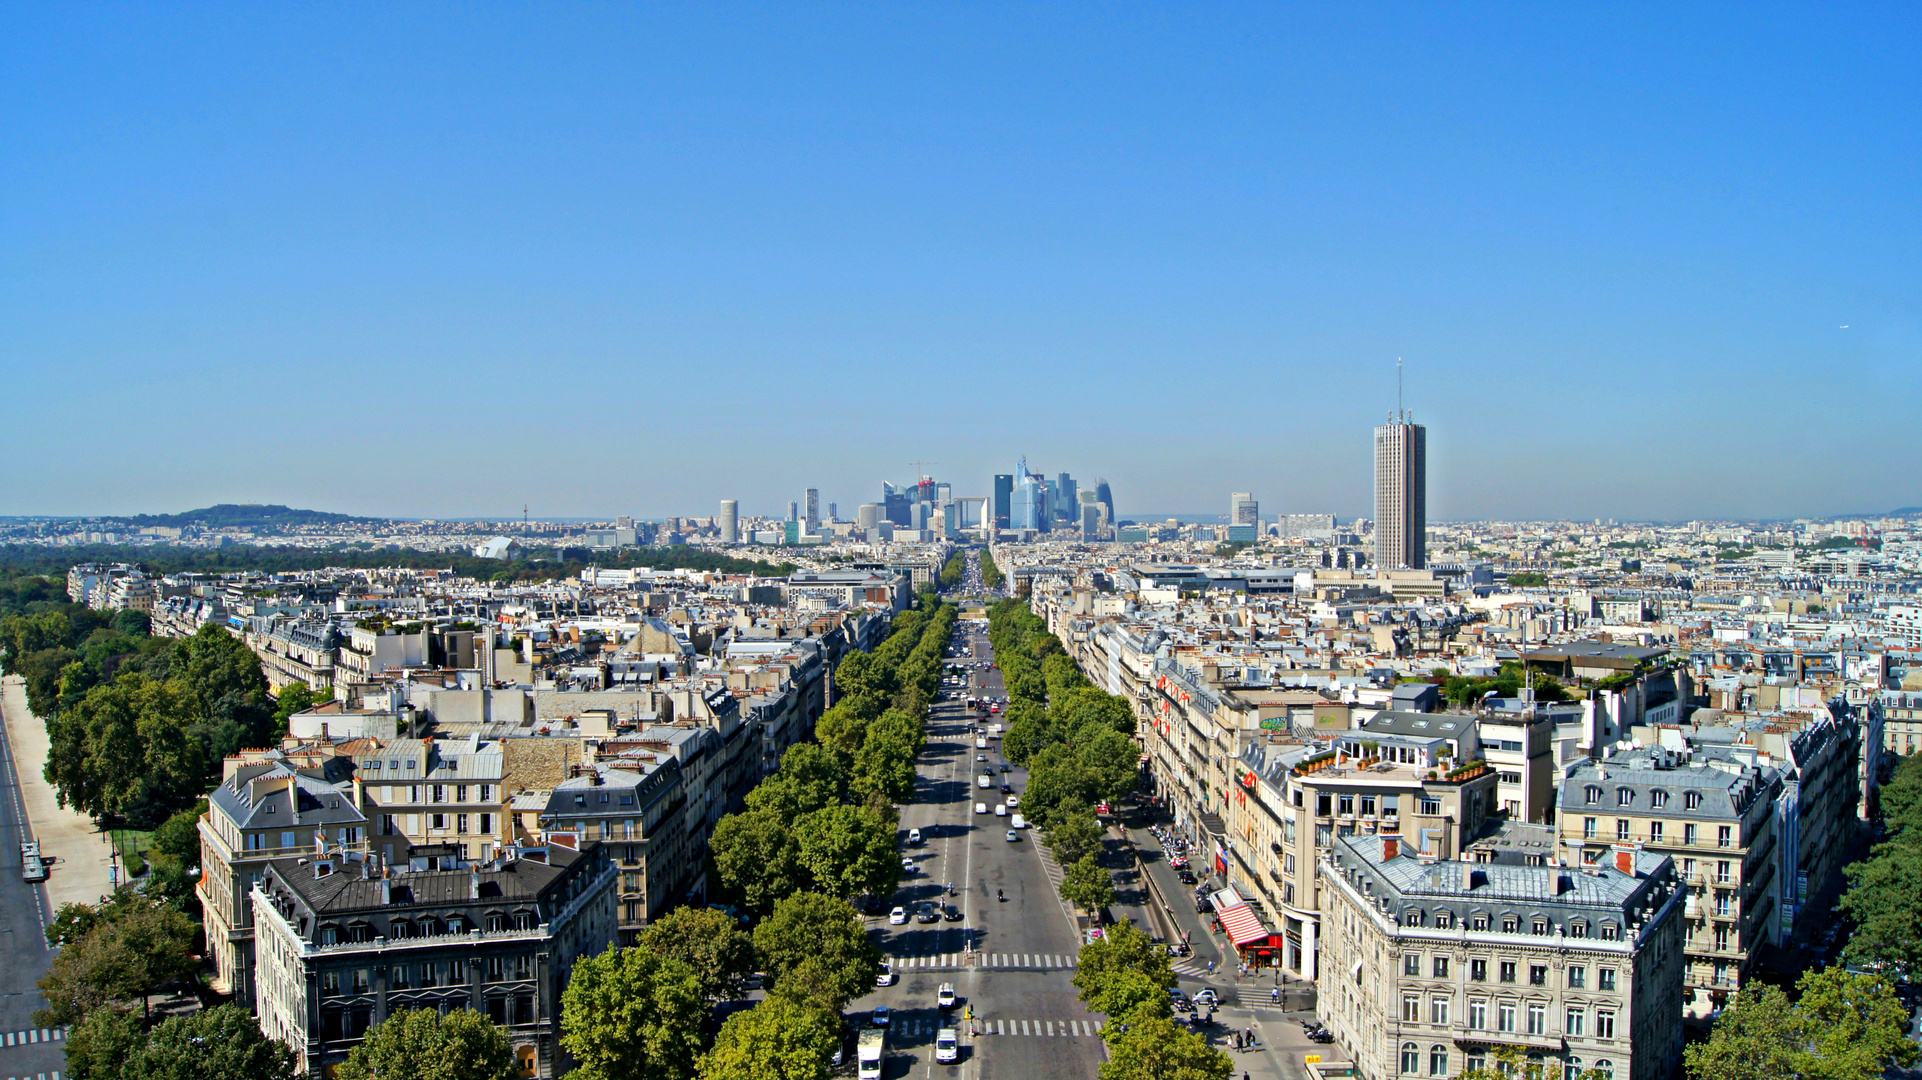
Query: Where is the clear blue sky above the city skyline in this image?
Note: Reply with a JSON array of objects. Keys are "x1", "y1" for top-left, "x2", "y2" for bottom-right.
[{"x1": 0, "y1": 4, "x2": 1922, "y2": 519}]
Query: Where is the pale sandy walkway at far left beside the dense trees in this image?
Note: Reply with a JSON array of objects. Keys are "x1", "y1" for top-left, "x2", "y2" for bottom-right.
[{"x1": 0, "y1": 675, "x2": 113, "y2": 907}]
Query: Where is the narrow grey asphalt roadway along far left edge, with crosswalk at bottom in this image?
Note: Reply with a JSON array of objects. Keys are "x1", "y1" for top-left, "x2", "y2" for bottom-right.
[{"x1": 0, "y1": 707, "x2": 65, "y2": 1074}]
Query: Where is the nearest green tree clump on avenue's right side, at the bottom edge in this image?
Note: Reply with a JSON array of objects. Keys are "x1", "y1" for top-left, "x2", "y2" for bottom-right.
[{"x1": 1074, "y1": 922, "x2": 1234, "y2": 1080}]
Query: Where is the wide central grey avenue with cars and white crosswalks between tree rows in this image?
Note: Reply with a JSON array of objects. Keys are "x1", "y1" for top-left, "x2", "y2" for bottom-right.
[{"x1": 850, "y1": 621, "x2": 1103, "y2": 1080}]
